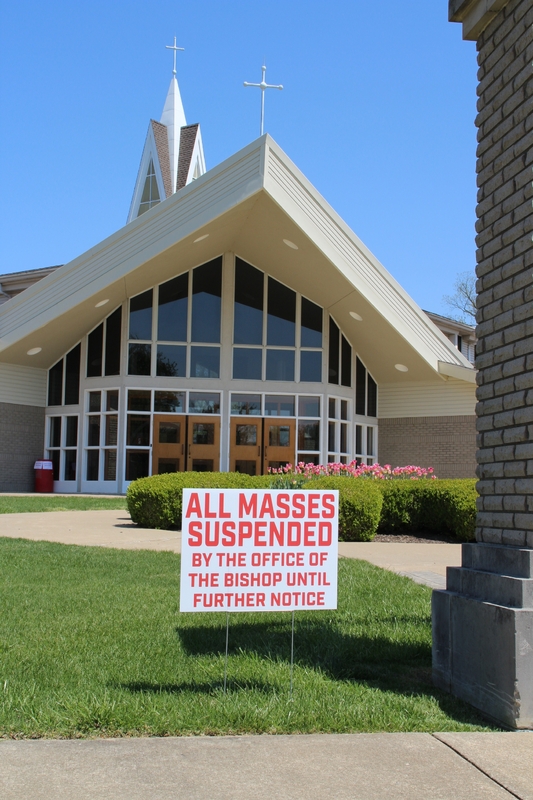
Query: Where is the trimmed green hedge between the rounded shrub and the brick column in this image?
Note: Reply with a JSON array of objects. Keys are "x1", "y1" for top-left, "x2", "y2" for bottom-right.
[{"x1": 377, "y1": 478, "x2": 477, "y2": 542}]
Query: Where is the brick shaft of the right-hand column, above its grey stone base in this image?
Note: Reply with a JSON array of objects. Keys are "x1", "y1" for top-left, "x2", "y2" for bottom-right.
[{"x1": 476, "y1": 0, "x2": 533, "y2": 547}]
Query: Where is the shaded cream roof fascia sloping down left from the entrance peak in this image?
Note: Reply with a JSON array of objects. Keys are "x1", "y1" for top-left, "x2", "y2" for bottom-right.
[{"x1": 0, "y1": 140, "x2": 265, "y2": 352}]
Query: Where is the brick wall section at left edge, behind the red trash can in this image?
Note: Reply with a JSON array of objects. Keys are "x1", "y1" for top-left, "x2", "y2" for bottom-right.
[{"x1": 0, "y1": 403, "x2": 44, "y2": 492}]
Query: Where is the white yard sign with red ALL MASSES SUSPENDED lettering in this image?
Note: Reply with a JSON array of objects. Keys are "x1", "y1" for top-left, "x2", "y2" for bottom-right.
[{"x1": 180, "y1": 489, "x2": 338, "y2": 612}]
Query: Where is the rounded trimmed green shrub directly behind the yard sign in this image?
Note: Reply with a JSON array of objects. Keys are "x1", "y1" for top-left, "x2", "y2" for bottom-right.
[{"x1": 126, "y1": 472, "x2": 383, "y2": 542}]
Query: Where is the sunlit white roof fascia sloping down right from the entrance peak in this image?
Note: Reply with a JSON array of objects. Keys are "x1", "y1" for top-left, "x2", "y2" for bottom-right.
[{"x1": 258, "y1": 134, "x2": 474, "y2": 373}]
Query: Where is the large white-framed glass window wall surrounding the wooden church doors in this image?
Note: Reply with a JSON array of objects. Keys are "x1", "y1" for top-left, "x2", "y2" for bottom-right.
[{"x1": 45, "y1": 257, "x2": 377, "y2": 490}]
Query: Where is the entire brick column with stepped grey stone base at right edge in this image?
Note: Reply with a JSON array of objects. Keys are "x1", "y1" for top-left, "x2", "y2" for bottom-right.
[{"x1": 433, "y1": 0, "x2": 533, "y2": 728}]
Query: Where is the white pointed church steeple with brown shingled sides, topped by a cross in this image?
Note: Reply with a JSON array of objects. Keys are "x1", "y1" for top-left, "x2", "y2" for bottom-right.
[{"x1": 128, "y1": 37, "x2": 206, "y2": 222}]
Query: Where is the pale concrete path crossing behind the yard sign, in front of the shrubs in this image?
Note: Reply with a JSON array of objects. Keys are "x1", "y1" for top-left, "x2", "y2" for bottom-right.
[{"x1": 0, "y1": 511, "x2": 461, "y2": 589}]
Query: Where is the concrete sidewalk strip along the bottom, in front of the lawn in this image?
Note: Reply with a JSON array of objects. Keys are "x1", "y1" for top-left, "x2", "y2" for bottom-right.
[{"x1": 0, "y1": 733, "x2": 533, "y2": 800}]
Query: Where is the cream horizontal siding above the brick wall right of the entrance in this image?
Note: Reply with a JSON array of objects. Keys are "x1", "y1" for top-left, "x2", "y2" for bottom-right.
[{"x1": 378, "y1": 378, "x2": 476, "y2": 419}]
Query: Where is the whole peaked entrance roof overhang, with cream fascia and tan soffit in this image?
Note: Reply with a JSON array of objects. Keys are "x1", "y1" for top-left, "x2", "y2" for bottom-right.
[{"x1": 0, "y1": 135, "x2": 475, "y2": 383}]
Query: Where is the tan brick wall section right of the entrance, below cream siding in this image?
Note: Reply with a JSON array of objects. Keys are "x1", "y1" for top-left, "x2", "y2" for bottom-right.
[{"x1": 378, "y1": 416, "x2": 476, "y2": 478}]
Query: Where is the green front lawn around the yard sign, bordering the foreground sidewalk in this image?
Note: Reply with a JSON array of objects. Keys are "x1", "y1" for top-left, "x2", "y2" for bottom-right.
[{"x1": 0, "y1": 539, "x2": 489, "y2": 738}]
